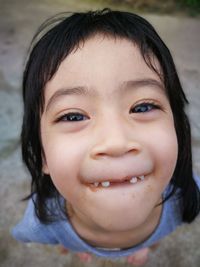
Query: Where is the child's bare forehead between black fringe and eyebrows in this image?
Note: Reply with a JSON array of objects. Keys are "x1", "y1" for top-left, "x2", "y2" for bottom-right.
[{"x1": 45, "y1": 35, "x2": 161, "y2": 104}]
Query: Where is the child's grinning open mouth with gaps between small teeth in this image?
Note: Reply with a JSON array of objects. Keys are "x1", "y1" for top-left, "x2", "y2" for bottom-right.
[{"x1": 89, "y1": 175, "x2": 145, "y2": 191}]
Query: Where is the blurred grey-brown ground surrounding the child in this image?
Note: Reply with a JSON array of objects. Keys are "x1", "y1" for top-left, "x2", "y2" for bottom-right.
[{"x1": 0, "y1": 0, "x2": 200, "y2": 267}]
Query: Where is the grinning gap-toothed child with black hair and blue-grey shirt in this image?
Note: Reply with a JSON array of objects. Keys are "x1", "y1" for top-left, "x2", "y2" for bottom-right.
[{"x1": 12, "y1": 9, "x2": 200, "y2": 266}]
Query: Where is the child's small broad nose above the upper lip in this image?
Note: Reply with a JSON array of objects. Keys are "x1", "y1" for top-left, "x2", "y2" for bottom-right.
[{"x1": 91, "y1": 115, "x2": 141, "y2": 159}]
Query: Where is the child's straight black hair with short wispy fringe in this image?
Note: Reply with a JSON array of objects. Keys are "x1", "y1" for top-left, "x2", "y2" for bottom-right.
[{"x1": 21, "y1": 9, "x2": 200, "y2": 223}]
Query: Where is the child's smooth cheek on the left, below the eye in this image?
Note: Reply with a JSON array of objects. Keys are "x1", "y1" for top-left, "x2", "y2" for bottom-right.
[{"x1": 42, "y1": 133, "x2": 86, "y2": 193}]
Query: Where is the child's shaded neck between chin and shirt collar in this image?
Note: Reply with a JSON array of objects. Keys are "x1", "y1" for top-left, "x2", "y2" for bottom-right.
[{"x1": 68, "y1": 205, "x2": 162, "y2": 249}]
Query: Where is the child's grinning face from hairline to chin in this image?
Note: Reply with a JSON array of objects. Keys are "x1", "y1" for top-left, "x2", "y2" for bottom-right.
[{"x1": 41, "y1": 36, "x2": 178, "y2": 231}]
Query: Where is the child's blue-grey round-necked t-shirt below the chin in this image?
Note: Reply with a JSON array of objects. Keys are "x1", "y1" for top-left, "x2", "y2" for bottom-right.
[{"x1": 12, "y1": 177, "x2": 200, "y2": 258}]
